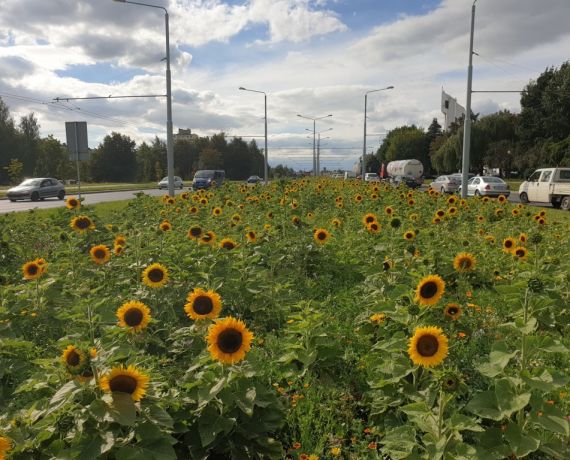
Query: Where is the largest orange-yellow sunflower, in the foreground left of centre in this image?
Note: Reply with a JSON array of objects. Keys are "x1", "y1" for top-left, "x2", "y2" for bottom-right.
[{"x1": 206, "y1": 317, "x2": 253, "y2": 364}]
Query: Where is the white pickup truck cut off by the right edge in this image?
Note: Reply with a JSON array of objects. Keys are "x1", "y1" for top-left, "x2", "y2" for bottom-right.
[{"x1": 519, "y1": 168, "x2": 570, "y2": 211}]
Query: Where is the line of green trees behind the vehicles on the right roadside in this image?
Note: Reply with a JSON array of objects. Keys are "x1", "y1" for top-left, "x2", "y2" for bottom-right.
[{"x1": 365, "y1": 61, "x2": 570, "y2": 177}]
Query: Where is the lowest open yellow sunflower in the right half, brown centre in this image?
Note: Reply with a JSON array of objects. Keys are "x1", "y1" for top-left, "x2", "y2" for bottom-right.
[{"x1": 408, "y1": 326, "x2": 448, "y2": 367}]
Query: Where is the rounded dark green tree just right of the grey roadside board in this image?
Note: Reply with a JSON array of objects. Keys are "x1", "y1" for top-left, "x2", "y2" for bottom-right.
[{"x1": 90, "y1": 132, "x2": 137, "y2": 182}]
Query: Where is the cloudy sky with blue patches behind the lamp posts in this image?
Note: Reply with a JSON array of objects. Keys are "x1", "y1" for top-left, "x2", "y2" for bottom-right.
[{"x1": 0, "y1": 0, "x2": 570, "y2": 169}]
